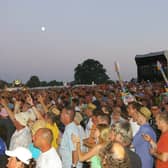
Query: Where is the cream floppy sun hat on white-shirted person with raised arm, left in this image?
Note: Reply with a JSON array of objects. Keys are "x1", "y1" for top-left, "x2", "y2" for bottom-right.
[{"x1": 15, "y1": 109, "x2": 36, "y2": 126}]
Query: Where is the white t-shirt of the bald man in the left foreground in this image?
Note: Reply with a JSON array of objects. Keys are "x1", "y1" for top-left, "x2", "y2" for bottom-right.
[{"x1": 36, "y1": 147, "x2": 62, "y2": 168}]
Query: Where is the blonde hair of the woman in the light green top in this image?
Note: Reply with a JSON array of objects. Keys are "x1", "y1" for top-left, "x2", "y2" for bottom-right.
[{"x1": 97, "y1": 124, "x2": 111, "y2": 142}]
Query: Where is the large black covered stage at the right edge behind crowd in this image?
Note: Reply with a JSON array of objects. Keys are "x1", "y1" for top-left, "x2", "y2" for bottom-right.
[{"x1": 135, "y1": 51, "x2": 168, "y2": 82}]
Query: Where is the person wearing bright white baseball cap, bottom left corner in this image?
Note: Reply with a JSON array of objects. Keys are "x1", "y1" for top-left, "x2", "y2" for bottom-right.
[{"x1": 5, "y1": 147, "x2": 35, "y2": 168}]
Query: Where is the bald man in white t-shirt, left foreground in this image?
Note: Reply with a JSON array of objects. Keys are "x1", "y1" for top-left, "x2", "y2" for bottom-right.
[{"x1": 33, "y1": 128, "x2": 62, "y2": 168}]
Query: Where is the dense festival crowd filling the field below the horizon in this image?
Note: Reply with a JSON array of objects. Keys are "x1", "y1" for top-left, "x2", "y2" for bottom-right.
[{"x1": 0, "y1": 82, "x2": 168, "y2": 168}]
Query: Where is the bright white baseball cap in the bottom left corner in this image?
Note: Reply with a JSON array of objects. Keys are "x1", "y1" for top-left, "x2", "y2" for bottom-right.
[{"x1": 5, "y1": 147, "x2": 32, "y2": 165}]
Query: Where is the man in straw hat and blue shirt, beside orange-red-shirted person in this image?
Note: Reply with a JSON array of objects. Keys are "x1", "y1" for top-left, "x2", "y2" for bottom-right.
[{"x1": 133, "y1": 107, "x2": 156, "y2": 168}]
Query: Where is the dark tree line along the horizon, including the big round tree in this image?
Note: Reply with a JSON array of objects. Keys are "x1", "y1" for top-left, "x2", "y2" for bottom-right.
[{"x1": 0, "y1": 59, "x2": 112, "y2": 89}]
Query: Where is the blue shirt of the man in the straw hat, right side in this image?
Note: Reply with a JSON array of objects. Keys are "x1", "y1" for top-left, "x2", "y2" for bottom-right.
[{"x1": 133, "y1": 123, "x2": 156, "y2": 168}]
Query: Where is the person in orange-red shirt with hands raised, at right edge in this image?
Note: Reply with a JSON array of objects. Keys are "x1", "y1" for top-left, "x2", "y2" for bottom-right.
[{"x1": 143, "y1": 111, "x2": 168, "y2": 168}]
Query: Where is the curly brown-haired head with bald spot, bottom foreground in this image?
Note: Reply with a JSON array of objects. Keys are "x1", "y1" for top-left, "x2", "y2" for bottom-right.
[{"x1": 99, "y1": 141, "x2": 130, "y2": 168}]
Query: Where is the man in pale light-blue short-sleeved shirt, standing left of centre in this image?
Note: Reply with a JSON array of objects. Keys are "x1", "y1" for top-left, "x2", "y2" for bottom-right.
[{"x1": 59, "y1": 107, "x2": 81, "y2": 168}]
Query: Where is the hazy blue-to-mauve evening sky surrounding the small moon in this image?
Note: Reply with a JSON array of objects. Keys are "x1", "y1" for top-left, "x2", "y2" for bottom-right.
[{"x1": 0, "y1": 0, "x2": 168, "y2": 82}]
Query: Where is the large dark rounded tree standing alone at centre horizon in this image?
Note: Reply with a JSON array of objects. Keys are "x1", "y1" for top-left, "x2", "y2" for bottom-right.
[{"x1": 74, "y1": 59, "x2": 109, "y2": 84}]
